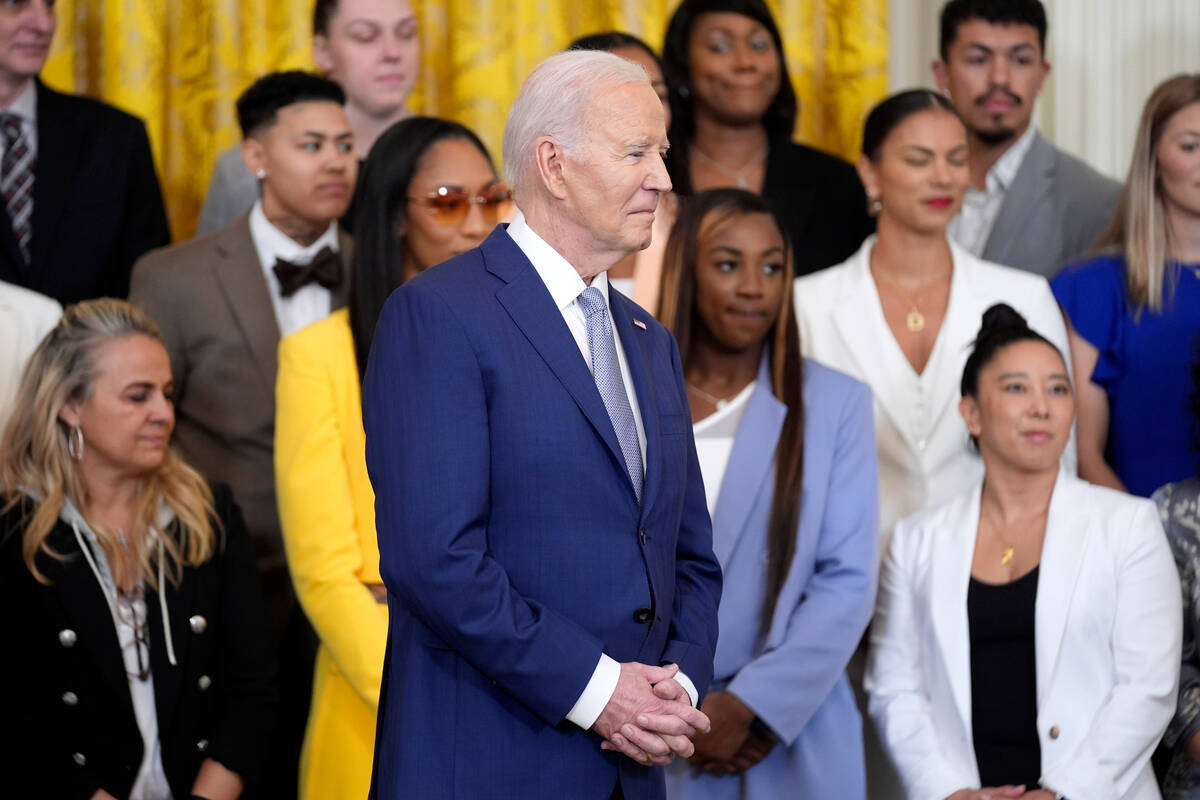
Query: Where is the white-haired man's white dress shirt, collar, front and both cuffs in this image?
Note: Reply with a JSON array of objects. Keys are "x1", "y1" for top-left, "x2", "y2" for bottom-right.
[{"x1": 508, "y1": 211, "x2": 698, "y2": 729}]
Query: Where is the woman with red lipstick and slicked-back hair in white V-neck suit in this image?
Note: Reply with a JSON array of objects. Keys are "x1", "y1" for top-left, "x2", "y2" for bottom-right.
[{"x1": 796, "y1": 89, "x2": 1075, "y2": 552}]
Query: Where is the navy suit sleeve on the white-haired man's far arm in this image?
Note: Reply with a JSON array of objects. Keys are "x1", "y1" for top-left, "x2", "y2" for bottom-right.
[{"x1": 662, "y1": 339, "x2": 721, "y2": 702}]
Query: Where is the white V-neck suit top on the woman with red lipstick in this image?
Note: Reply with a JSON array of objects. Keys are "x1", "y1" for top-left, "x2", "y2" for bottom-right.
[{"x1": 796, "y1": 236, "x2": 1075, "y2": 553}]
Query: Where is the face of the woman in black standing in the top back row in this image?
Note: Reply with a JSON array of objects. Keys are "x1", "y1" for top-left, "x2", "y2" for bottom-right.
[{"x1": 688, "y1": 11, "x2": 782, "y2": 125}]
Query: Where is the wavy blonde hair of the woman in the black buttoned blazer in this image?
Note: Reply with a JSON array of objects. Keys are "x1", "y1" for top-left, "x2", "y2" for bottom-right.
[{"x1": 0, "y1": 299, "x2": 218, "y2": 588}]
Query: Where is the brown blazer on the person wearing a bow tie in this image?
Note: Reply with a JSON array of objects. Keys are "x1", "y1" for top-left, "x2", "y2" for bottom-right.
[{"x1": 130, "y1": 216, "x2": 353, "y2": 640}]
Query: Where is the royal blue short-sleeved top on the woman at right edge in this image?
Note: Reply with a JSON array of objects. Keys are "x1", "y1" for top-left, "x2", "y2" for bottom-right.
[{"x1": 1050, "y1": 255, "x2": 1200, "y2": 497}]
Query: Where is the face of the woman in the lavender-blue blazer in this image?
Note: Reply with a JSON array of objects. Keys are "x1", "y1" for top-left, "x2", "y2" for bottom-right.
[{"x1": 696, "y1": 211, "x2": 788, "y2": 351}]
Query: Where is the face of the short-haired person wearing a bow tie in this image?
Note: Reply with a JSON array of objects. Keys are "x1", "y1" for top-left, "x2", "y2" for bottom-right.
[{"x1": 242, "y1": 101, "x2": 359, "y2": 227}]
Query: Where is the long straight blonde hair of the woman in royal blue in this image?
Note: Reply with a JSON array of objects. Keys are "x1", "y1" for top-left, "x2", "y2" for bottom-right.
[{"x1": 1094, "y1": 73, "x2": 1200, "y2": 314}]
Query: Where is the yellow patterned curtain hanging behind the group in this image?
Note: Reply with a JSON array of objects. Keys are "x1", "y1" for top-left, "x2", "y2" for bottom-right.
[{"x1": 43, "y1": 0, "x2": 888, "y2": 240}]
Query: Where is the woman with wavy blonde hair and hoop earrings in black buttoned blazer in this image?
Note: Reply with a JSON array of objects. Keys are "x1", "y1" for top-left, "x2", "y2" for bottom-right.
[{"x1": 0, "y1": 300, "x2": 274, "y2": 800}]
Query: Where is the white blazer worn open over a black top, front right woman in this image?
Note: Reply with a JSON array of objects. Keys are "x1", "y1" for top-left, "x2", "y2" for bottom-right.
[{"x1": 864, "y1": 470, "x2": 1183, "y2": 800}]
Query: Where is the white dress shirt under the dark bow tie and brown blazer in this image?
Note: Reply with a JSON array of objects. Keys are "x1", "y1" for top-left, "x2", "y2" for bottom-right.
[{"x1": 250, "y1": 200, "x2": 338, "y2": 337}]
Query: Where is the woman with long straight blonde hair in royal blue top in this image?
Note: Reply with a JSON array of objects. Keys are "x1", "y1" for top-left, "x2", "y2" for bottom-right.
[{"x1": 1050, "y1": 74, "x2": 1200, "y2": 497}]
